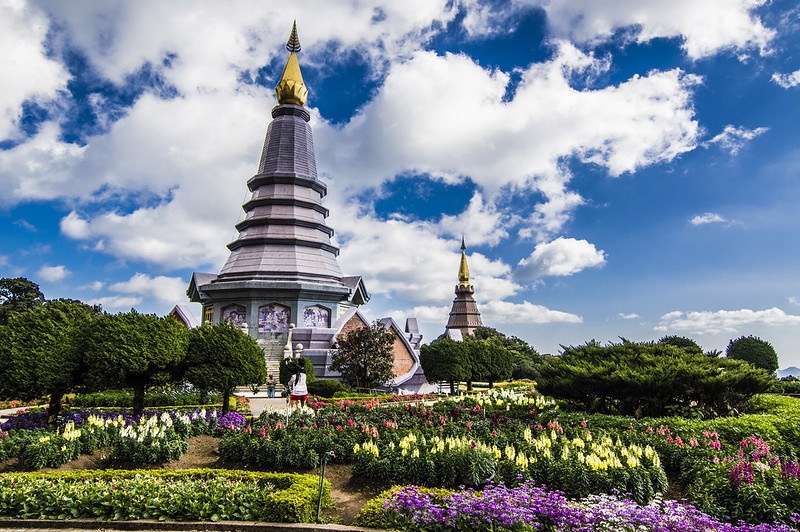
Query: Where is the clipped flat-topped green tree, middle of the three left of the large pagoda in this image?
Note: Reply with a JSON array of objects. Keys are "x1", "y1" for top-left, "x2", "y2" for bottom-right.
[{"x1": 84, "y1": 310, "x2": 187, "y2": 413}]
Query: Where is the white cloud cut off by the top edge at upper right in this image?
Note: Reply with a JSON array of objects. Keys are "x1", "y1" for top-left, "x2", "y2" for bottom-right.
[{"x1": 532, "y1": 0, "x2": 776, "y2": 59}]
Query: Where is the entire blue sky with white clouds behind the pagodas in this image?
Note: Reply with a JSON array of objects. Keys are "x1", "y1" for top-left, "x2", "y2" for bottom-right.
[{"x1": 0, "y1": 0, "x2": 800, "y2": 367}]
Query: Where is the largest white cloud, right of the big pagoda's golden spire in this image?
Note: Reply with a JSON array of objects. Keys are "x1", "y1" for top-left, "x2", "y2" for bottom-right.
[{"x1": 314, "y1": 42, "x2": 700, "y2": 239}]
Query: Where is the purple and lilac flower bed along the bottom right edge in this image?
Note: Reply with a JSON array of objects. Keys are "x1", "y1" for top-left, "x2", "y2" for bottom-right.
[{"x1": 353, "y1": 482, "x2": 800, "y2": 532}]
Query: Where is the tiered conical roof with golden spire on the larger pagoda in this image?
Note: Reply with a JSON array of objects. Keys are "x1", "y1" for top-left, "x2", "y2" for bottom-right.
[{"x1": 215, "y1": 26, "x2": 342, "y2": 286}]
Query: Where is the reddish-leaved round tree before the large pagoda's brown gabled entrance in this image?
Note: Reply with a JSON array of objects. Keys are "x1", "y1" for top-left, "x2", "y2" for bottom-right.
[{"x1": 330, "y1": 322, "x2": 395, "y2": 388}]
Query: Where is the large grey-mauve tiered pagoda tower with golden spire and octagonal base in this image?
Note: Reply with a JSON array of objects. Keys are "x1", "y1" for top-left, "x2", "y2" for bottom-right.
[{"x1": 187, "y1": 26, "x2": 369, "y2": 365}]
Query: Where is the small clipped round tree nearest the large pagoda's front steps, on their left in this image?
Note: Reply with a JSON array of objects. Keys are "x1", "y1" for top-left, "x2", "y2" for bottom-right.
[{"x1": 185, "y1": 322, "x2": 267, "y2": 415}]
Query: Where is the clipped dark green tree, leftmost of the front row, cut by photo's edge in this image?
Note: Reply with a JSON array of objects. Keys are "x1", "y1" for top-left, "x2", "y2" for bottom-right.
[{"x1": 0, "y1": 299, "x2": 96, "y2": 418}]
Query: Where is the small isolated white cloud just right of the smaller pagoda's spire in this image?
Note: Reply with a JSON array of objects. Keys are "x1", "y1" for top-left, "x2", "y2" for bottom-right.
[{"x1": 514, "y1": 237, "x2": 605, "y2": 280}]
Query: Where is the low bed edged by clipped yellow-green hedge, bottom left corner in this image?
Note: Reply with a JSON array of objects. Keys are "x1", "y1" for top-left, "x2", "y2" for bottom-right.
[{"x1": 0, "y1": 469, "x2": 331, "y2": 523}]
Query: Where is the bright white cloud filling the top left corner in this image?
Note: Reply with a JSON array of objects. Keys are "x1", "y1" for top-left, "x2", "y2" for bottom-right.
[{"x1": 0, "y1": 0, "x2": 69, "y2": 140}]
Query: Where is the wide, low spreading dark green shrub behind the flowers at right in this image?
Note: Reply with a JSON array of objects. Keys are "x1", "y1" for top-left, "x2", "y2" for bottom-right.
[{"x1": 539, "y1": 341, "x2": 771, "y2": 418}]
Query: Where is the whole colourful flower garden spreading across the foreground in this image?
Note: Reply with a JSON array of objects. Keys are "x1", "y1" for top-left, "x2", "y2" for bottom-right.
[{"x1": 0, "y1": 386, "x2": 800, "y2": 531}]
